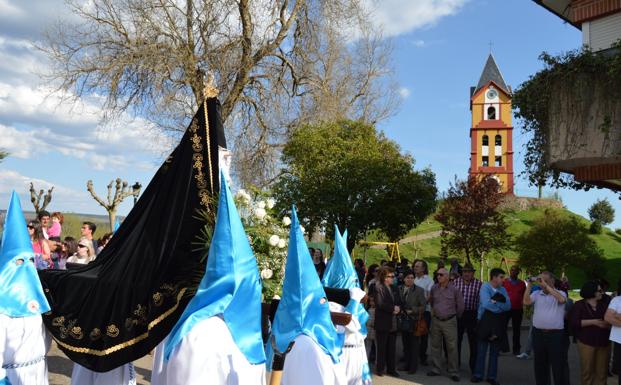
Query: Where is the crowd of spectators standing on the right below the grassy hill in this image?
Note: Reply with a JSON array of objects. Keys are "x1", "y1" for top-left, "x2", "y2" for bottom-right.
[{"x1": 314, "y1": 258, "x2": 621, "y2": 385}]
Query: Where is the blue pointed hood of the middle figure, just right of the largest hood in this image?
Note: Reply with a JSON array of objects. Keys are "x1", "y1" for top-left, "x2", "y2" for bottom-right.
[{"x1": 268, "y1": 206, "x2": 342, "y2": 363}]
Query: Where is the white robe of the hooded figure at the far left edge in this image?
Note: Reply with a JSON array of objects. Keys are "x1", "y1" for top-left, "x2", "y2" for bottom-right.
[{"x1": 0, "y1": 314, "x2": 50, "y2": 385}]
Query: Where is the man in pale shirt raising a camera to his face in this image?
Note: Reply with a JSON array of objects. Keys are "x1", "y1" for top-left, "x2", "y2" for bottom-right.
[{"x1": 523, "y1": 272, "x2": 567, "y2": 385}]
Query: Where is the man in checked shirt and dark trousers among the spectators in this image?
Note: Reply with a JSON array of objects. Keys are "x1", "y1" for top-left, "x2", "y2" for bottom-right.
[{"x1": 453, "y1": 263, "x2": 481, "y2": 373}]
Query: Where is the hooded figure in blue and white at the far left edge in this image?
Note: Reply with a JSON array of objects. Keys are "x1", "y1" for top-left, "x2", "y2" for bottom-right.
[{"x1": 0, "y1": 192, "x2": 50, "y2": 385}]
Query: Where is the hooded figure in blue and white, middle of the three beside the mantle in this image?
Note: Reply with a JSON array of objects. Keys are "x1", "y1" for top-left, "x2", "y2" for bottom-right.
[{"x1": 268, "y1": 206, "x2": 347, "y2": 385}]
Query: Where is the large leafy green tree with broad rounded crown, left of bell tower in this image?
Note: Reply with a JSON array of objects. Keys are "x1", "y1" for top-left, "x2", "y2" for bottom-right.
[{"x1": 274, "y1": 120, "x2": 437, "y2": 248}]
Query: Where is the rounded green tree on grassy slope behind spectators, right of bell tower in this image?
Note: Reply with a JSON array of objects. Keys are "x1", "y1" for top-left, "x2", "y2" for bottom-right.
[{"x1": 515, "y1": 209, "x2": 602, "y2": 278}]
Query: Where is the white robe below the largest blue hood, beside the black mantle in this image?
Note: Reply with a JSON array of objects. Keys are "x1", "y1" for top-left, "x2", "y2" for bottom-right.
[{"x1": 151, "y1": 316, "x2": 266, "y2": 385}]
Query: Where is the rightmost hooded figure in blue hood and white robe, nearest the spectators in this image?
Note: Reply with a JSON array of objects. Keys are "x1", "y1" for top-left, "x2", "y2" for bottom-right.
[{"x1": 321, "y1": 226, "x2": 372, "y2": 385}]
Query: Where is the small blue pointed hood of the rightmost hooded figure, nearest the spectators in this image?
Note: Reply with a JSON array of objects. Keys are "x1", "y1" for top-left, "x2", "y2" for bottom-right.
[{"x1": 321, "y1": 225, "x2": 360, "y2": 289}]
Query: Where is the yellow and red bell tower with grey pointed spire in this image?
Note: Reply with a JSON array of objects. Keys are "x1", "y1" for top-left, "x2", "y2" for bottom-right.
[{"x1": 469, "y1": 53, "x2": 513, "y2": 195}]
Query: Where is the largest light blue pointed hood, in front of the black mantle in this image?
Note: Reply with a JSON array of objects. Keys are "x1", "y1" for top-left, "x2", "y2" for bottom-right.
[{"x1": 164, "y1": 172, "x2": 265, "y2": 364}]
